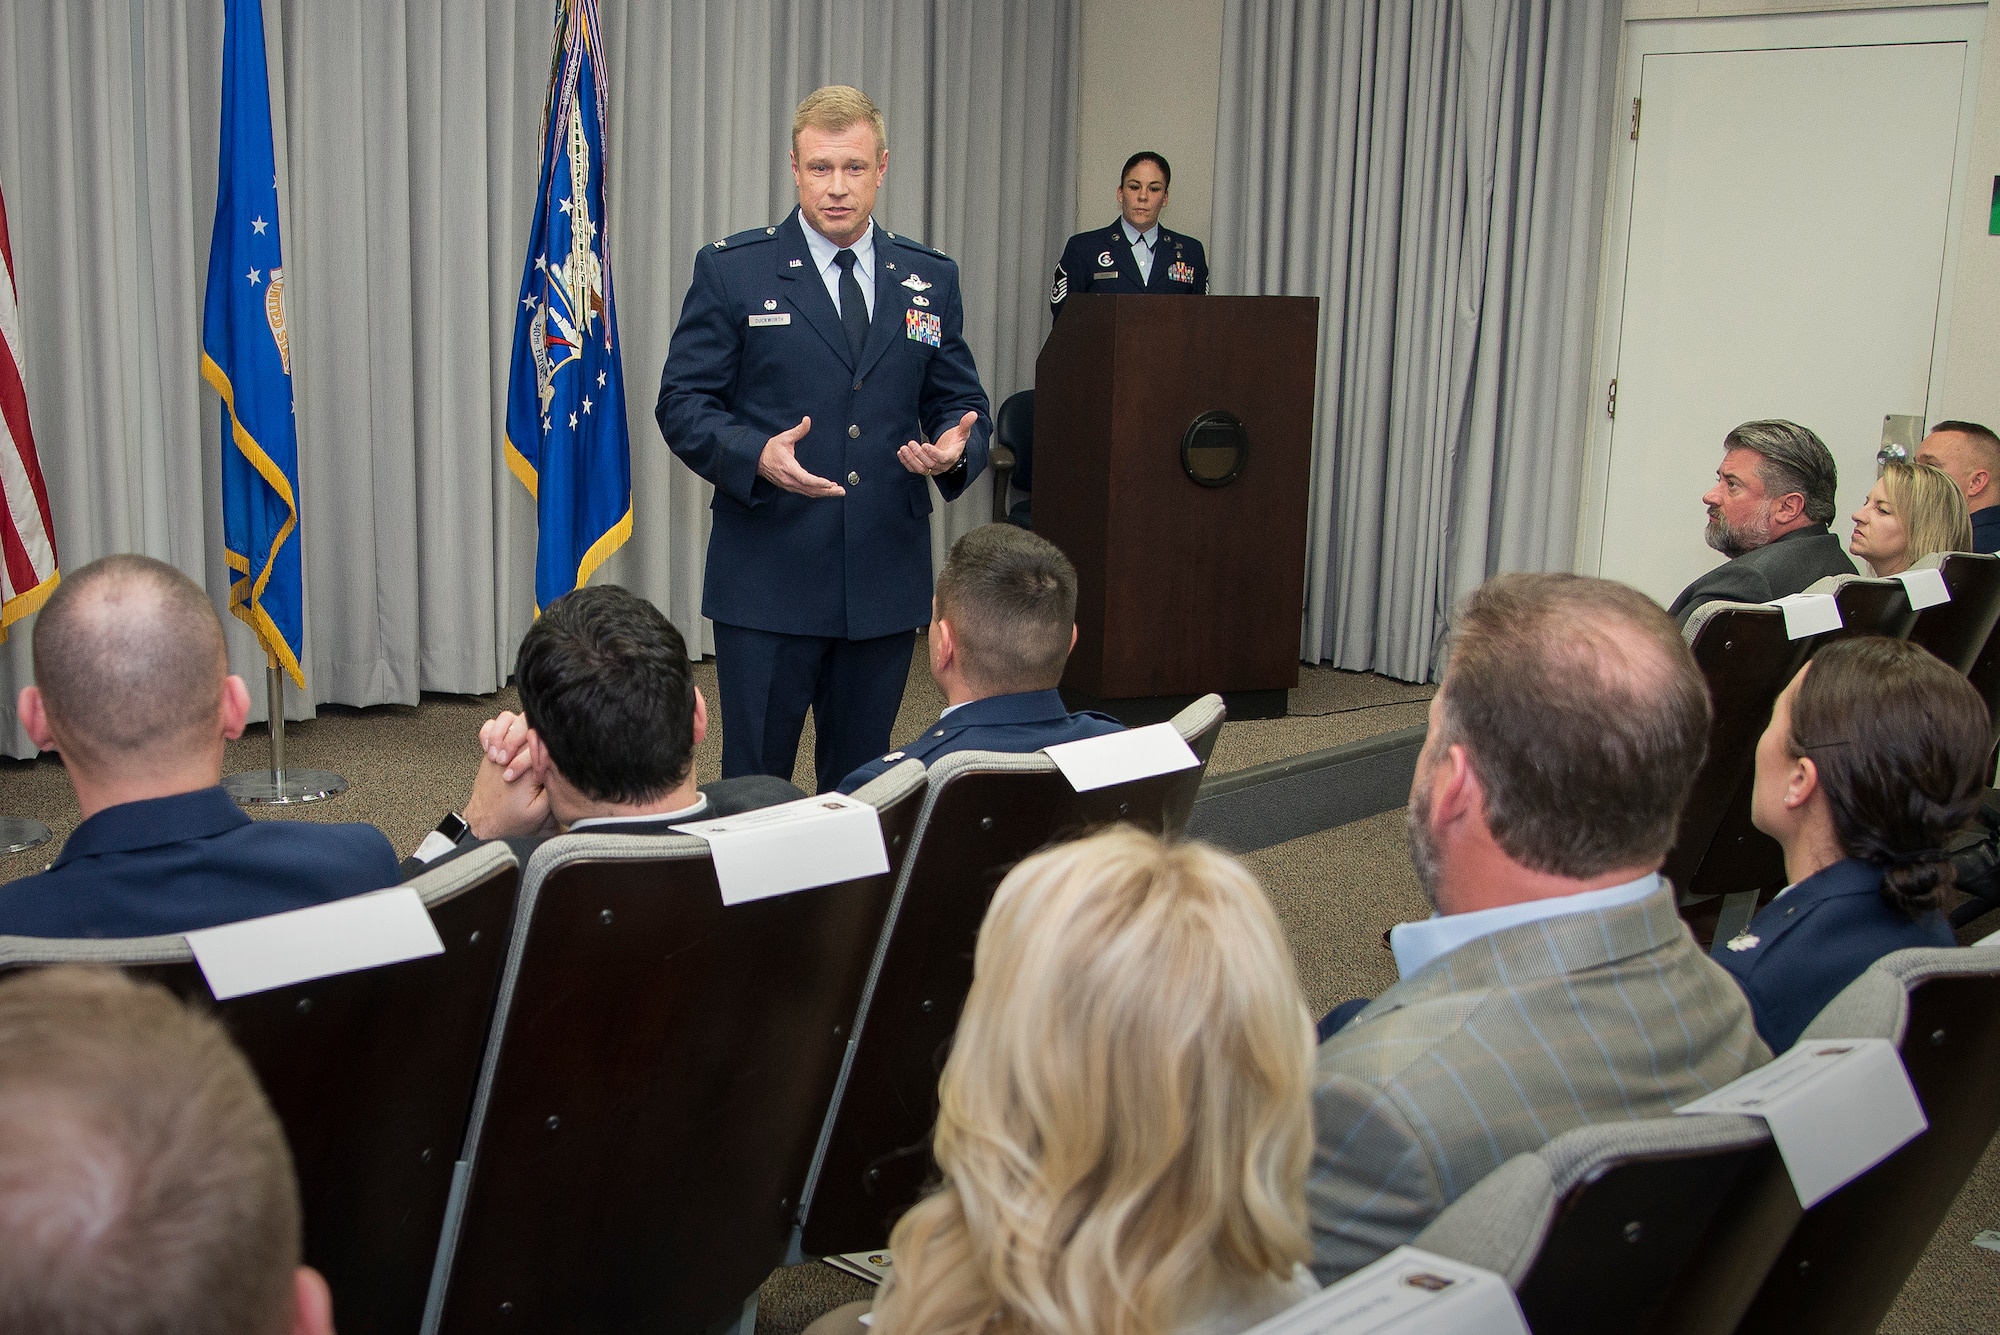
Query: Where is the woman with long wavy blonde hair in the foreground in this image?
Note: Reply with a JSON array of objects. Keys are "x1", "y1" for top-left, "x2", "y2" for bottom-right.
[{"x1": 808, "y1": 829, "x2": 1318, "y2": 1335}]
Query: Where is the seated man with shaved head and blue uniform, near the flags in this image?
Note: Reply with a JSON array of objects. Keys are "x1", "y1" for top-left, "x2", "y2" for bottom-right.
[{"x1": 0, "y1": 556, "x2": 398, "y2": 937}]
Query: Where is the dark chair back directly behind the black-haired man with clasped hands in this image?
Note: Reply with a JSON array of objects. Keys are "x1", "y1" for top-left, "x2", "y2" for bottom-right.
[{"x1": 424, "y1": 761, "x2": 924, "y2": 1331}]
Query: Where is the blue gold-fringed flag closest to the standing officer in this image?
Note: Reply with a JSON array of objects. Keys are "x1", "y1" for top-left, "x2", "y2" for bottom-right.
[{"x1": 506, "y1": 0, "x2": 632, "y2": 610}]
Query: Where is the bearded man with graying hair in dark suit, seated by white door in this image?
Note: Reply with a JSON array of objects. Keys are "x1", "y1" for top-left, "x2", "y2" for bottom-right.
[{"x1": 1668, "y1": 420, "x2": 1854, "y2": 626}]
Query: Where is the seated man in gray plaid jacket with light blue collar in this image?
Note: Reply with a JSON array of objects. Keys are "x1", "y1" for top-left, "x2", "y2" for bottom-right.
[{"x1": 1306, "y1": 574, "x2": 1770, "y2": 1283}]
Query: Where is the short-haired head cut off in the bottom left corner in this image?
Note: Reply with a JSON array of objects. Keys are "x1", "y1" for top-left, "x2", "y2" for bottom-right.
[{"x1": 0, "y1": 967, "x2": 300, "y2": 1335}]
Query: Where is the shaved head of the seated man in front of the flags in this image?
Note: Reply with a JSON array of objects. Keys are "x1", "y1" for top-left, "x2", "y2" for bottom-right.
[{"x1": 34, "y1": 554, "x2": 228, "y2": 767}]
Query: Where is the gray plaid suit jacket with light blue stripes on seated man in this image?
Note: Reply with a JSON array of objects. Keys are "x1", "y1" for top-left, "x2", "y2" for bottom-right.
[{"x1": 1306, "y1": 885, "x2": 1770, "y2": 1283}]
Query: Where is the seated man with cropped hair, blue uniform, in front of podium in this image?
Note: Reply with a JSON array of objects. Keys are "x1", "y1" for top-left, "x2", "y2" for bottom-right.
[{"x1": 840, "y1": 524, "x2": 1124, "y2": 793}]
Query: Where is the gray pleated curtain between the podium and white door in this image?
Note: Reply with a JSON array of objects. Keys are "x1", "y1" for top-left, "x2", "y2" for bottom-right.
[{"x1": 1210, "y1": 0, "x2": 1620, "y2": 681}]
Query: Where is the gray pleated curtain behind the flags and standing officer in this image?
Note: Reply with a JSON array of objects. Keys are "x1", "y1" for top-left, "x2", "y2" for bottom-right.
[{"x1": 0, "y1": 0, "x2": 1078, "y2": 755}]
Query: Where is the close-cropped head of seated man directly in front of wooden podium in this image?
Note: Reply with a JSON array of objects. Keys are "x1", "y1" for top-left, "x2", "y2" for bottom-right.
[{"x1": 938, "y1": 524, "x2": 1076, "y2": 695}]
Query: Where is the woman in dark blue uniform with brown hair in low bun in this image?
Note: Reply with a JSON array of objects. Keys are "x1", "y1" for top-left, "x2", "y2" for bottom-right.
[{"x1": 1714, "y1": 636, "x2": 1990, "y2": 1053}]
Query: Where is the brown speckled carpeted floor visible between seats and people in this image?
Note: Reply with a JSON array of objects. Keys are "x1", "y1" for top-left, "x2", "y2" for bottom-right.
[{"x1": 0, "y1": 640, "x2": 2000, "y2": 1335}]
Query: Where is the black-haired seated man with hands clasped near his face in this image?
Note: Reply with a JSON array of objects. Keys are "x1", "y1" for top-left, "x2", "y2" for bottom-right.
[{"x1": 402, "y1": 584, "x2": 804, "y2": 875}]
